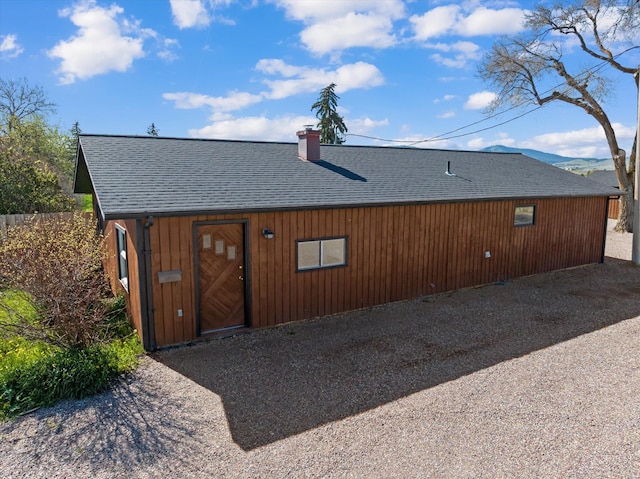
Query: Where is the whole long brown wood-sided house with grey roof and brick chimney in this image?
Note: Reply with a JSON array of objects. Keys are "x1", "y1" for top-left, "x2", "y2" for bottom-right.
[{"x1": 75, "y1": 130, "x2": 612, "y2": 350}]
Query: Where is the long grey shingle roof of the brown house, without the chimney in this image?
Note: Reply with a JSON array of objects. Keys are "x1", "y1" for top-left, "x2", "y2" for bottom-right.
[{"x1": 75, "y1": 135, "x2": 612, "y2": 219}]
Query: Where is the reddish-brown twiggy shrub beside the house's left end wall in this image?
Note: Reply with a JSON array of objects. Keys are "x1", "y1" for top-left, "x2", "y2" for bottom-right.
[{"x1": 0, "y1": 214, "x2": 110, "y2": 348}]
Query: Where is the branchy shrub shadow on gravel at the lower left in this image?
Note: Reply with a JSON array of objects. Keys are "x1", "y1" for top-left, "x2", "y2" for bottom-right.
[{"x1": 0, "y1": 376, "x2": 201, "y2": 478}]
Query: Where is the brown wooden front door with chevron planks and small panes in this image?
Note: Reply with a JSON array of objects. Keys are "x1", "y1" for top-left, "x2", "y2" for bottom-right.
[{"x1": 196, "y1": 223, "x2": 245, "y2": 334}]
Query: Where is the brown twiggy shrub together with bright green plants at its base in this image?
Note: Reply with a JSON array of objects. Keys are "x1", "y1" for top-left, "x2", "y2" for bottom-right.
[{"x1": 0, "y1": 215, "x2": 143, "y2": 419}]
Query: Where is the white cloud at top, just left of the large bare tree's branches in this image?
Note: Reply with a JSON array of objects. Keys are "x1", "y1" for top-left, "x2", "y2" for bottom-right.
[{"x1": 409, "y1": 5, "x2": 525, "y2": 41}]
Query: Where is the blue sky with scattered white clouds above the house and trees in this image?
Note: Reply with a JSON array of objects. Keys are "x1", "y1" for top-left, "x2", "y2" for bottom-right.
[{"x1": 0, "y1": 0, "x2": 640, "y2": 158}]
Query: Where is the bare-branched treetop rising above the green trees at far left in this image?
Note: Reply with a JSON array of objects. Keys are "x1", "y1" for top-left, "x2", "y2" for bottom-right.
[{"x1": 0, "y1": 78, "x2": 56, "y2": 133}]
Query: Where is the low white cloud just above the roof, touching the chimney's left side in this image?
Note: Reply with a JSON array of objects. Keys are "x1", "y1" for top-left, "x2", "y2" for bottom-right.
[{"x1": 189, "y1": 116, "x2": 317, "y2": 142}]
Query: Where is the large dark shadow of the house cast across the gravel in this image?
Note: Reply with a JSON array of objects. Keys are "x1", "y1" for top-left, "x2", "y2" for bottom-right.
[{"x1": 153, "y1": 258, "x2": 640, "y2": 450}]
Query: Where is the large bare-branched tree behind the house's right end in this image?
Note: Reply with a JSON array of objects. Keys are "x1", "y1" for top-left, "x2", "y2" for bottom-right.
[{"x1": 478, "y1": 0, "x2": 640, "y2": 231}]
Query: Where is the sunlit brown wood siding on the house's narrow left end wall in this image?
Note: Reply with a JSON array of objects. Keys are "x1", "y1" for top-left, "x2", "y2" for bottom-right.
[{"x1": 103, "y1": 220, "x2": 142, "y2": 340}]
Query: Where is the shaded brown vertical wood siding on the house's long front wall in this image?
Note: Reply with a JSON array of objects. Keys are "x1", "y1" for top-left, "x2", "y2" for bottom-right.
[{"x1": 127, "y1": 198, "x2": 607, "y2": 346}]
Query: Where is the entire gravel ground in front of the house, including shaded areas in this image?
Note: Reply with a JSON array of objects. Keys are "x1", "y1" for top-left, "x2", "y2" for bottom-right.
[{"x1": 0, "y1": 226, "x2": 640, "y2": 479}]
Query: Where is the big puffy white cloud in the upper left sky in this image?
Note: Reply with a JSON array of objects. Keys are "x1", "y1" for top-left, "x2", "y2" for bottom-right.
[{"x1": 48, "y1": 0, "x2": 147, "y2": 84}]
